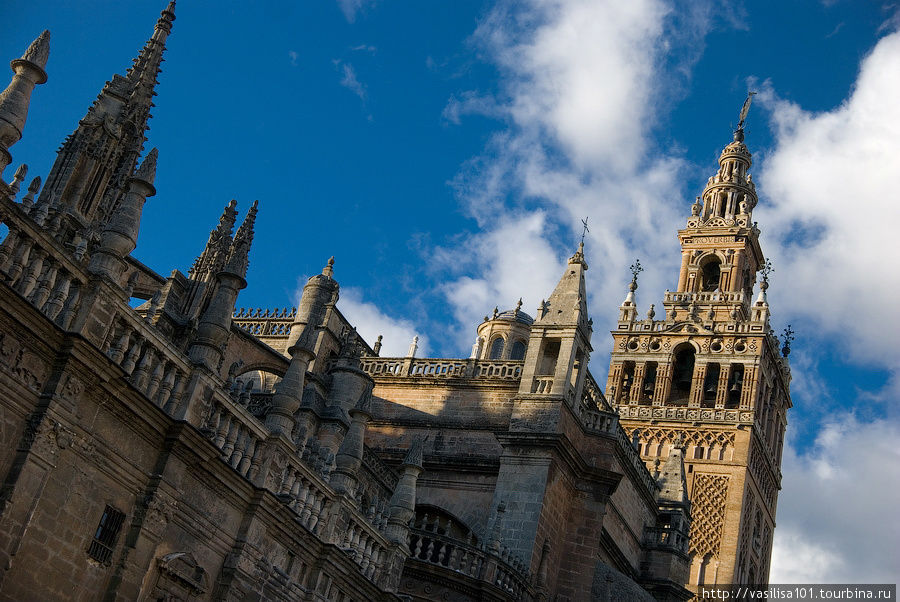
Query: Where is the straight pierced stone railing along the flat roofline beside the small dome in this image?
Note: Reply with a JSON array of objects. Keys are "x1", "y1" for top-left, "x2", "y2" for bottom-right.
[{"x1": 360, "y1": 356, "x2": 524, "y2": 381}]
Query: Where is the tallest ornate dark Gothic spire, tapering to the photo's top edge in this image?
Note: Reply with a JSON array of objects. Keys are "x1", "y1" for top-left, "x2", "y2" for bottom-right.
[{"x1": 40, "y1": 3, "x2": 175, "y2": 224}]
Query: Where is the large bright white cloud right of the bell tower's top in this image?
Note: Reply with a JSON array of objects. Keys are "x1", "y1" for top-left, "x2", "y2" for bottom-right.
[{"x1": 755, "y1": 33, "x2": 900, "y2": 371}]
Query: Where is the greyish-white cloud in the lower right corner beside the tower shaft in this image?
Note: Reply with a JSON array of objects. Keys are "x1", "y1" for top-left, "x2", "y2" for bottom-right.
[{"x1": 769, "y1": 413, "x2": 900, "y2": 583}]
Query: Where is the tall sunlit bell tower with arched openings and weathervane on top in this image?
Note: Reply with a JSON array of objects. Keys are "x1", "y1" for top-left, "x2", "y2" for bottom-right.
[{"x1": 607, "y1": 94, "x2": 792, "y2": 590}]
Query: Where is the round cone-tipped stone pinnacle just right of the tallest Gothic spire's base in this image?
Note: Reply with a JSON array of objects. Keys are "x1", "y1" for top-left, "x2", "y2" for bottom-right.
[{"x1": 90, "y1": 148, "x2": 158, "y2": 282}]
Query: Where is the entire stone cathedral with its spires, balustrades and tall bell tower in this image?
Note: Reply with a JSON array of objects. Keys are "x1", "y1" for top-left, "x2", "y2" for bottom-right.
[{"x1": 0, "y1": 2, "x2": 791, "y2": 602}]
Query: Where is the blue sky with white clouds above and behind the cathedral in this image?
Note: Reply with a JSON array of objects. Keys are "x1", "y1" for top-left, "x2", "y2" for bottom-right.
[{"x1": 0, "y1": 0, "x2": 900, "y2": 582}]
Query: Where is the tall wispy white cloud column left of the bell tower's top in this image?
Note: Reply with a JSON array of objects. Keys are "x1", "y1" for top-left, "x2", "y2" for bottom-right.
[{"x1": 443, "y1": 0, "x2": 712, "y2": 356}]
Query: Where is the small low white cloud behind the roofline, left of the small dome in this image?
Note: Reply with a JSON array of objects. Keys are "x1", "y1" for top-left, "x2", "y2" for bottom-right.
[{"x1": 338, "y1": 287, "x2": 429, "y2": 357}]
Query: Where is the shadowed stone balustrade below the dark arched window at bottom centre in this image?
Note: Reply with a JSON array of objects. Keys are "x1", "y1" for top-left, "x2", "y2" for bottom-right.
[{"x1": 409, "y1": 525, "x2": 532, "y2": 601}]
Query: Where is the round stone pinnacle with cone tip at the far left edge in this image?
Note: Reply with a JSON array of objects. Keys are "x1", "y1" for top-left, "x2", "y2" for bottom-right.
[{"x1": 0, "y1": 30, "x2": 50, "y2": 175}]
